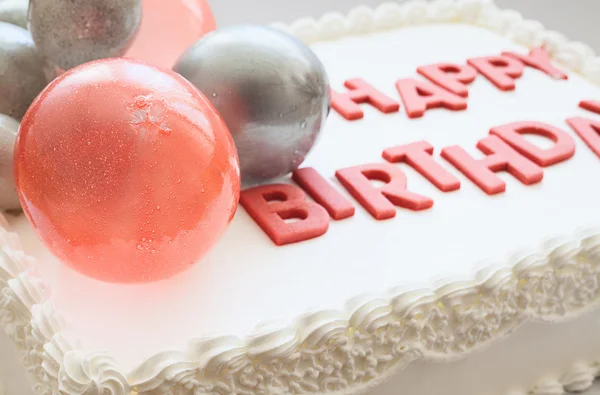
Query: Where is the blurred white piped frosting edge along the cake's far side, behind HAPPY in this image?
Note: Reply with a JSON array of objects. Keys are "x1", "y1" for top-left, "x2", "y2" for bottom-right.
[{"x1": 271, "y1": 0, "x2": 600, "y2": 84}]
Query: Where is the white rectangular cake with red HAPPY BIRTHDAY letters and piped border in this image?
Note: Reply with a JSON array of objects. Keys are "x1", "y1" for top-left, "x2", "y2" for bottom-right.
[{"x1": 0, "y1": 0, "x2": 600, "y2": 395}]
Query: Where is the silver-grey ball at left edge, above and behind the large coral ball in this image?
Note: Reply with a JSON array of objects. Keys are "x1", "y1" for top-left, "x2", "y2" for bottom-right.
[{"x1": 0, "y1": 22, "x2": 47, "y2": 120}]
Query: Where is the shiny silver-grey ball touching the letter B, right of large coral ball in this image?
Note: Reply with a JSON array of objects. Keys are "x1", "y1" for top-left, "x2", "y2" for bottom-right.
[{"x1": 173, "y1": 25, "x2": 329, "y2": 184}]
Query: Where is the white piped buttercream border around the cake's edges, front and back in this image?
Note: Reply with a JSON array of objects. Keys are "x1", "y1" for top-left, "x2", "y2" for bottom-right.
[{"x1": 0, "y1": 0, "x2": 600, "y2": 395}]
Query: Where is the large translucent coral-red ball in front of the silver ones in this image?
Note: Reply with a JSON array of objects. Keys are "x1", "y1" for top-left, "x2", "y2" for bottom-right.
[{"x1": 14, "y1": 59, "x2": 240, "y2": 283}]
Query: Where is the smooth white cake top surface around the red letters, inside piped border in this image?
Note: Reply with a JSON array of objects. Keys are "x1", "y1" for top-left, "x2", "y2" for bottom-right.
[{"x1": 8, "y1": 20, "x2": 600, "y2": 367}]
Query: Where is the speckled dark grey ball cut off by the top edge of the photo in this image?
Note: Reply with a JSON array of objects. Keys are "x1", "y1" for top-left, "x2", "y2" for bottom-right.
[{"x1": 28, "y1": 0, "x2": 142, "y2": 70}]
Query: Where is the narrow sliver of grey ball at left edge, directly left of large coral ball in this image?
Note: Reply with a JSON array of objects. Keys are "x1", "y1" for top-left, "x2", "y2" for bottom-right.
[{"x1": 0, "y1": 114, "x2": 21, "y2": 210}]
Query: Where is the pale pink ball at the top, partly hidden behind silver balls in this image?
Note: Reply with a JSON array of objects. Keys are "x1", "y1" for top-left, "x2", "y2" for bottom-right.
[{"x1": 125, "y1": 0, "x2": 216, "y2": 68}]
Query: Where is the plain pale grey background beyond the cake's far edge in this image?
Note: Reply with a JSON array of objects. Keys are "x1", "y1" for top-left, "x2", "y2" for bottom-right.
[{"x1": 209, "y1": 0, "x2": 600, "y2": 53}]
